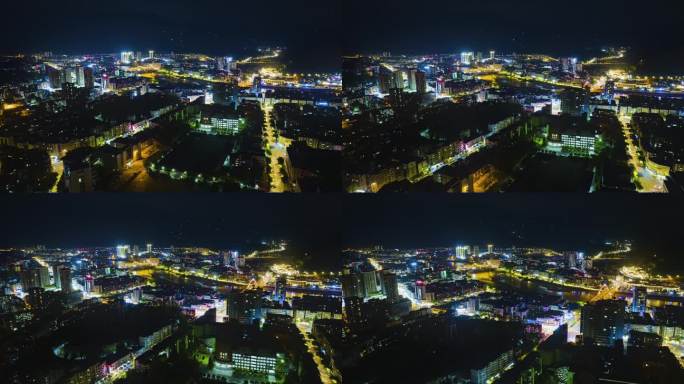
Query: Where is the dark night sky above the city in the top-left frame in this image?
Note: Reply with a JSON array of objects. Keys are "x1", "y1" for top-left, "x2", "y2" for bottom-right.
[{"x1": 0, "y1": 0, "x2": 340, "y2": 70}]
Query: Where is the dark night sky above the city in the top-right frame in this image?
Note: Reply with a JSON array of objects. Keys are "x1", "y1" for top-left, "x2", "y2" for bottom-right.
[{"x1": 343, "y1": 0, "x2": 684, "y2": 72}]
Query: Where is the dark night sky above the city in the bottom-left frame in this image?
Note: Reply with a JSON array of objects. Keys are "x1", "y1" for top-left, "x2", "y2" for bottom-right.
[{"x1": 0, "y1": 193, "x2": 340, "y2": 252}]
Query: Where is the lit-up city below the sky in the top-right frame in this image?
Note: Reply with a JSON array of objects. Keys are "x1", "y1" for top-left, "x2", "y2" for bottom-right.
[{"x1": 342, "y1": 47, "x2": 684, "y2": 193}]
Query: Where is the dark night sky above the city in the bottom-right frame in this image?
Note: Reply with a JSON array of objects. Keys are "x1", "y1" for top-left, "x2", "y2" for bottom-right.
[{"x1": 344, "y1": 193, "x2": 684, "y2": 249}]
